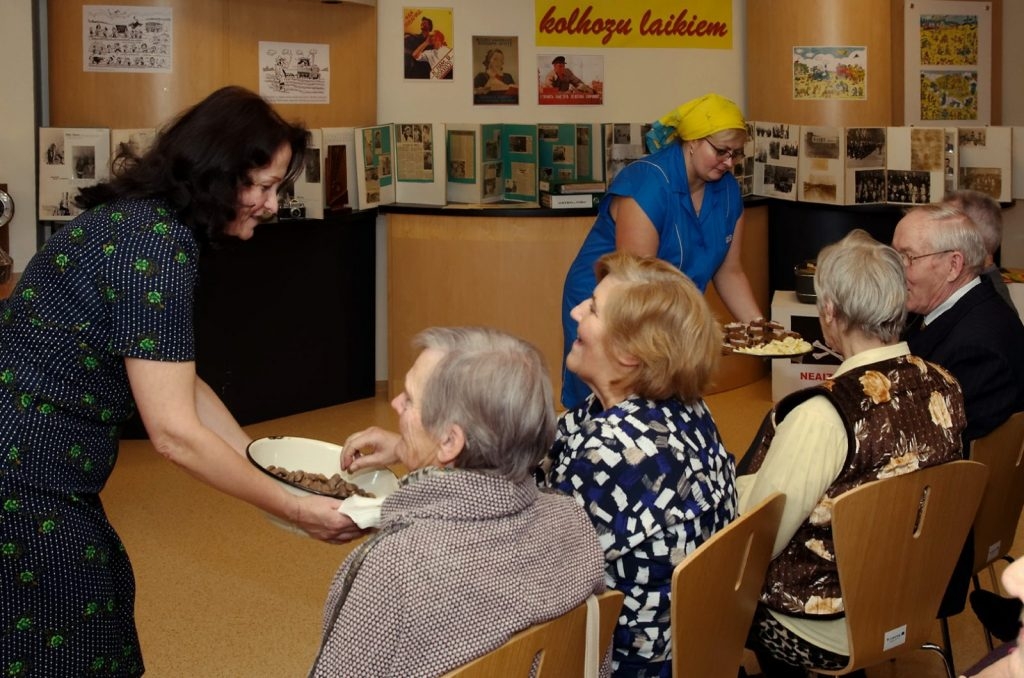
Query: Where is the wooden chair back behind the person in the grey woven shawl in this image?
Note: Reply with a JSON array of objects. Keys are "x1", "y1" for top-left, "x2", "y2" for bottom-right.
[{"x1": 445, "y1": 591, "x2": 625, "y2": 678}]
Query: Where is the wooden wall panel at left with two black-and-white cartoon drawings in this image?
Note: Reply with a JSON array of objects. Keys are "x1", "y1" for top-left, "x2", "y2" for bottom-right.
[{"x1": 47, "y1": 0, "x2": 377, "y2": 128}]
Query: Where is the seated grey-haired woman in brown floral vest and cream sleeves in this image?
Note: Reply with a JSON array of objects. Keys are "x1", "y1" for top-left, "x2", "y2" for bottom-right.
[{"x1": 736, "y1": 230, "x2": 966, "y2": 677}]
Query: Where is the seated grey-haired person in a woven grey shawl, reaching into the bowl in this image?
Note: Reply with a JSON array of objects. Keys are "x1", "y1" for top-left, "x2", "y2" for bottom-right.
[{"x1": 321, "y1": 328, "x2": 607, "y2": 677}]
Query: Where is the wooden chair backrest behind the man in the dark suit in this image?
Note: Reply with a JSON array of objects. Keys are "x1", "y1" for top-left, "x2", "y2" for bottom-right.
[{"x1": 971, "y1": 412, "x2": 1024, "y2": 574}]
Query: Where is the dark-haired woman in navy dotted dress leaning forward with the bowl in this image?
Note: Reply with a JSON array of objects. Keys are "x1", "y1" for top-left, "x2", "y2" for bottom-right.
[{"x1": 0, "y1": 87, "x2": 359, "y2": 678}]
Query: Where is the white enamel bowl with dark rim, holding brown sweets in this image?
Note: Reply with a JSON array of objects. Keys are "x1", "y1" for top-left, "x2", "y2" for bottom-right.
[{"x1": 246, "y1": 435, "x2": 398, "y2": 535}]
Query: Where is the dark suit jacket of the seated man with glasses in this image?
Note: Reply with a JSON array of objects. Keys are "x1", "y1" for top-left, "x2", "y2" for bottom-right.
[{"x1": 907, "y1": 278, "x2": 1024, "y2": 456}]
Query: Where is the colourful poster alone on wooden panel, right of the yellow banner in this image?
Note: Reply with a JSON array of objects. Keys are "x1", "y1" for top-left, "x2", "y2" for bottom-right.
[{"x1": 793, "y1": 47, "x2": 867, "y2": 100}]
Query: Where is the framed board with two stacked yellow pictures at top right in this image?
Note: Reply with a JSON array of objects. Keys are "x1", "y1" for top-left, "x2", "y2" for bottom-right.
[{"x1": 904, "y1": 0, "x2": 992, "y2": 126}]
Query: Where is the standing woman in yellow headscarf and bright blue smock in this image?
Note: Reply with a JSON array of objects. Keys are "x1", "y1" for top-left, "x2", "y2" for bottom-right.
[{"x1": 562, "y1": 94, "x2": 762, "y2": 409}]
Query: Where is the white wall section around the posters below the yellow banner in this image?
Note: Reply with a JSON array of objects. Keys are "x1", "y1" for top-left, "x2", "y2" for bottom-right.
[{"x1": 377, "y1": 0, "x2": 746, "y2": 123}]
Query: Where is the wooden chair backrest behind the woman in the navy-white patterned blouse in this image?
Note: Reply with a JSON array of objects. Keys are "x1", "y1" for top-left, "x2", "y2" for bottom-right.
[{"x1": 672, "y1": 492, "x2": 785, "y2": 678}]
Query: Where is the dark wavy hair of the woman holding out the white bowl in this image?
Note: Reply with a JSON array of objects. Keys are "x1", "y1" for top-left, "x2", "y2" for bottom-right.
[{"x1": 75, "y1": 86, "x2": 309, "y2": 245}]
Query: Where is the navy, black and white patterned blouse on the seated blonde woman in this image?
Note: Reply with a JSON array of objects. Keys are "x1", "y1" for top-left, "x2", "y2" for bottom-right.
[{"x1": 548, "y1": 395, "x2": 736, "y2": 677}]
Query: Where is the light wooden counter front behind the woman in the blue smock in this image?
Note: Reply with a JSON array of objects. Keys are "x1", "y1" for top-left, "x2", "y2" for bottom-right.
[{"x1": 381, "y1": 205, "x2": 769, "y2": 402}]
